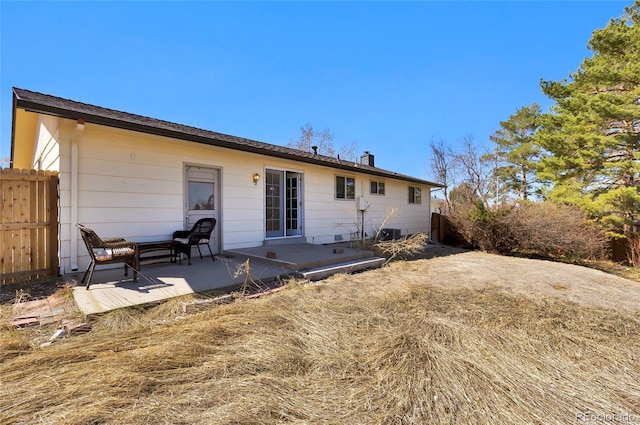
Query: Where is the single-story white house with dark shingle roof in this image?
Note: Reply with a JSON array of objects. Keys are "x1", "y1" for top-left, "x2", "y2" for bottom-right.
[{"x1": 11, "y1": 88, "x2": 440, "y2": 274}]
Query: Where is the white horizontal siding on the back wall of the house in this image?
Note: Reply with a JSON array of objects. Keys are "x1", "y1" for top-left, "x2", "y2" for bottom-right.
[{"x1": 27, "y1": 113, "x2": 430, "y2": 271}]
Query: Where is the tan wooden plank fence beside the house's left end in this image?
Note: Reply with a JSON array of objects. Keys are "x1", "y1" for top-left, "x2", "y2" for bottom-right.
[{"x1": 0, "y1": 168, "x2": 59, "y2": 286}]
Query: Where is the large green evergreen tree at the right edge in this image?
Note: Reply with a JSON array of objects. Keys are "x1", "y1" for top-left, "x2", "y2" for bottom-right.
[{"x1": 536, "y1": 0, "x2": 640, "y2": 236}]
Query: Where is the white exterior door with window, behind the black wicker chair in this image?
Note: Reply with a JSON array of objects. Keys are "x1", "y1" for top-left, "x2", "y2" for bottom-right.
[{"x1": 185, "y1": 165, "x2": 222, "y2": 254}]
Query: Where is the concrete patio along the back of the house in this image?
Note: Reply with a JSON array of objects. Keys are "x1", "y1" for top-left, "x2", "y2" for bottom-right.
[{"x1": 69, "y1": 244, "x2": 384, "y2": 315}]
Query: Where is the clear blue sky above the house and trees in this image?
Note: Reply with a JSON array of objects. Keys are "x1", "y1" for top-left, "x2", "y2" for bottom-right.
[{"x1": 0, "y1": 0, "x2": 632, "y2": 179}]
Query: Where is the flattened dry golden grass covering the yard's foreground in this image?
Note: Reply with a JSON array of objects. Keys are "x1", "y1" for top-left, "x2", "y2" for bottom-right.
[{"x1": 0, "y1": 255, "x2": 640, "y2": 425}]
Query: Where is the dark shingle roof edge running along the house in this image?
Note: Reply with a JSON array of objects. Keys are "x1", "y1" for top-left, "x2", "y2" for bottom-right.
[{"x1": 12, "y1": 88, "x2": 441, "y2": 187}]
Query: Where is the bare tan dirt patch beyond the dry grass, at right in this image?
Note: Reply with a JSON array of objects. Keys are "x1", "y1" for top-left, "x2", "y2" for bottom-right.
[{"x1": 389, "y1": 245, "x2": 640, "y2": 314}]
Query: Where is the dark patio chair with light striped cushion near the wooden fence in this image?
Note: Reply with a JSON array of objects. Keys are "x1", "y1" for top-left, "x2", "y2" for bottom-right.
[{"x1": 76, "y1": 223, "x2": 140, "y2": 289}]
